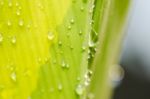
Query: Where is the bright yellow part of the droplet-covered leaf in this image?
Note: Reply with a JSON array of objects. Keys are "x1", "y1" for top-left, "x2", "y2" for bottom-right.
[{"x1": 0, "y1": 0, "x2": 71, "y2": 99}]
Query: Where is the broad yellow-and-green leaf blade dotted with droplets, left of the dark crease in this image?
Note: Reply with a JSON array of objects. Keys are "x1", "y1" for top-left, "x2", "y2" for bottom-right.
[{"x1": 0, "y1": 0, "x2": 92, "y2": 99}]
